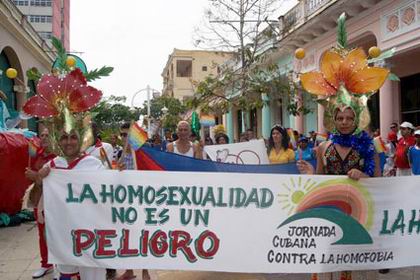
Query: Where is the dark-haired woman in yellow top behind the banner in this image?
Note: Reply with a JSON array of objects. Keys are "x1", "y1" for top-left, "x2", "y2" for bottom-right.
[{"x1": 268, "y1": 125, "x2": 295, "y2": 164}]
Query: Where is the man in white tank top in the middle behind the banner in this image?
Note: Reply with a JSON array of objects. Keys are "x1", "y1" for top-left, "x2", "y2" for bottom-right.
[{"x1": 166, "y1": 121, "x2": 203, "y2": 159}]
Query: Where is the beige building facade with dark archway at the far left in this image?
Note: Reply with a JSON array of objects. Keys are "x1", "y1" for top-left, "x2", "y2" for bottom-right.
[{"x1": 0, "y1": 0, "x2": 53, "y2": 131}]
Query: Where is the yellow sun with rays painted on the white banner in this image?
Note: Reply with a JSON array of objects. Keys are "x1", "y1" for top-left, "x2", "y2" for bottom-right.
[{"x1": 278, "y1": 177, "x2": 317, "y2": 215}]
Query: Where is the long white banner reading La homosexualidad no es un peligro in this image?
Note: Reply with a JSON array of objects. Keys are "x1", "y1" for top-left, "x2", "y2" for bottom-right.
[{"x1": 44, "y1": 170, "x2": 420, "y2": 273}]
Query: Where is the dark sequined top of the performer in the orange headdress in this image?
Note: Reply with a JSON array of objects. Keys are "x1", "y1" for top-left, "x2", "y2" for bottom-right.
[{"x1": 324, "y1": 144, "x2": 363, "y2": 175}]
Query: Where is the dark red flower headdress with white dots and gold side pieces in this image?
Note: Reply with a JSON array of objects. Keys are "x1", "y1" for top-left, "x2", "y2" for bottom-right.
[{"x1": 23, "y1": 68, "x2": 102, "y2": 155}]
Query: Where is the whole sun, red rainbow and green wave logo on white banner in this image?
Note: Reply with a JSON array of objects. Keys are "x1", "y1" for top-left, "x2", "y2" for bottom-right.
[{"x1": 278, "y1": 177, "x2": 374, "y2": 245}]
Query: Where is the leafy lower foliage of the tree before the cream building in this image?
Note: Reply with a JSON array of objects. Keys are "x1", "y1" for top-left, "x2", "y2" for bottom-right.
[{"x1": 187, "y1": 61, "x2": 312, "y2": 116}]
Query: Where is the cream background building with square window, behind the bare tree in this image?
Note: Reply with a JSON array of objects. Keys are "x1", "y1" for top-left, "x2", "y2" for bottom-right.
[{"x1": 162, "y1": 49, "x2": 233, "y2": 101}]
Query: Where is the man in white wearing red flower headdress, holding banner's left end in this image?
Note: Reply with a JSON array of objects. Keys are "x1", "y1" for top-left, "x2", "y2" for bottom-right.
[{"x1": 23, "y1": 68, "x2": 108, "y2": 280}]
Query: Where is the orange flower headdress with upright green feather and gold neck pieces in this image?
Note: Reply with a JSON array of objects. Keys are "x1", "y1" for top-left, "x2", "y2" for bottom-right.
[{"x1": 296, "y1": 13, "x2": 394, "y2": 134}]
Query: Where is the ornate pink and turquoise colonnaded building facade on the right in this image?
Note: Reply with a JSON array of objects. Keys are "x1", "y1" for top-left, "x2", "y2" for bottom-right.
[{"x1": 225, "y1": 0, "x2": 420, "y2": 138}]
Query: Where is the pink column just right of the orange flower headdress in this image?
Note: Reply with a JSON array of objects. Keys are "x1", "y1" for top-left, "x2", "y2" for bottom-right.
[{"x1": 377, "y1": 80, "x2": 398, "y2": 139}]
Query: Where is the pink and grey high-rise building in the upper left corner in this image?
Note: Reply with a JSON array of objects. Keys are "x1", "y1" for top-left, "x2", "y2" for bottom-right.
[{"x1": 11, "y1": 0, "x2": 70, "y2": 50}]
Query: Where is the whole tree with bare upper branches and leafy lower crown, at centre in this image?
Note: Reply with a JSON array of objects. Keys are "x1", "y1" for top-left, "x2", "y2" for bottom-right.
[{"x1": 188, "y1": 0, "x2": 308, "y2": 115}]
